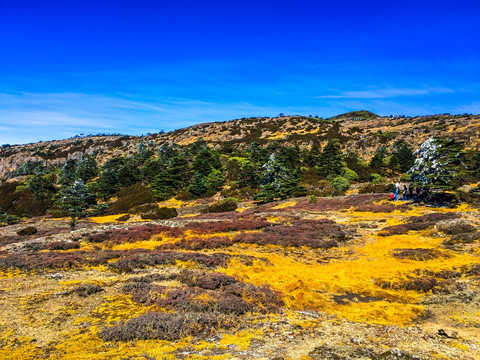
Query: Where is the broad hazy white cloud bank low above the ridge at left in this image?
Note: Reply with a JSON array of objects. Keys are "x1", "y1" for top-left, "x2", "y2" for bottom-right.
[{"x1": 0, "y1": 93, "x2": 322, "y2": 144}]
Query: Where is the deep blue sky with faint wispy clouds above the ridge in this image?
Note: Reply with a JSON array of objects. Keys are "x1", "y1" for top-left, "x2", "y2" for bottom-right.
[{"x1": 0, "y1": 0, "x2": 480, "y2": 144}]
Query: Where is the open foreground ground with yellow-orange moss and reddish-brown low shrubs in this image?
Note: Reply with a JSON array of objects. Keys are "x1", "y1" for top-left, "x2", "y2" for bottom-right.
[{"x1": 0, "y1": 195, "x2": 480, "y2": 359}]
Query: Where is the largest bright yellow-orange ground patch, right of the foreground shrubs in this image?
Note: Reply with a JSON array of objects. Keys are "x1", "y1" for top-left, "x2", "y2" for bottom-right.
[{"x1": 222, "y1": 226, "x2": 478, "y2": 325}]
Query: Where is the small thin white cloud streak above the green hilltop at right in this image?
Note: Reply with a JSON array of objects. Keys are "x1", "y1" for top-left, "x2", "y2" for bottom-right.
[{"x1": 316, "y1": 87, "x2": 454, "y2": 99}]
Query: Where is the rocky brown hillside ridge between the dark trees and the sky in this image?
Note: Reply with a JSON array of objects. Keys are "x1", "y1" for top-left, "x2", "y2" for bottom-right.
[{"x1": 0, "y1": 114, "x2": 480, "y2": 179}]
